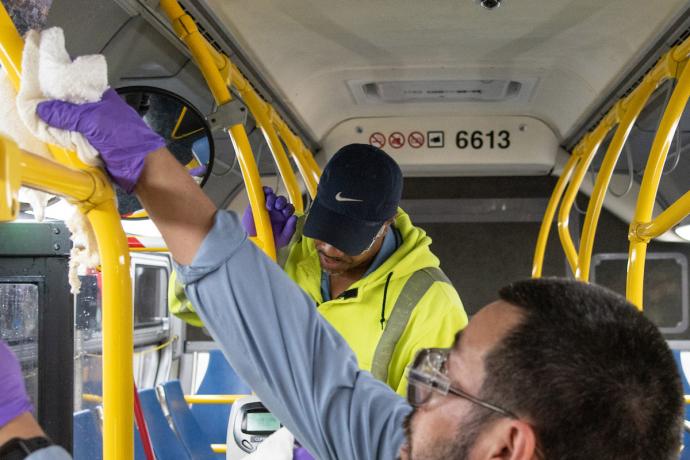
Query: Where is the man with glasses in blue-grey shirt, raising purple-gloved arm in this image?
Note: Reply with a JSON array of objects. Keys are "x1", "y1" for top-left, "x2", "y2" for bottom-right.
[{"x1": 38, "y1": 94, "x2": 683, "y2": 460}]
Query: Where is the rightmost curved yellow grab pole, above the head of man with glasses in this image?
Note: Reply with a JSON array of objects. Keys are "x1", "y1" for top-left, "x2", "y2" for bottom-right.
[{"x1": 626, "y1": 54, "x2": 690, "y2": 310}]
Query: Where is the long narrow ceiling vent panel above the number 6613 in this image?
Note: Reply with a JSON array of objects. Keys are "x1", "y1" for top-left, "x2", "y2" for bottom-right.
[{"x1": 348, "y1": 79, "x2": 536, "y2": 104}]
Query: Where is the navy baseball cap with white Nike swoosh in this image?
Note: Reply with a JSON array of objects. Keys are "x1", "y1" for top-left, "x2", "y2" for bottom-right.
[{"x1": 304, "y1": 144, "x2": 403, "y2": 255}]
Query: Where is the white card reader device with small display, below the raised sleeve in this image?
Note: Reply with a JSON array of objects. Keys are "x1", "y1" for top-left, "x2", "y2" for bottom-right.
[{"x1": 227, "y1": 396, "x2": 282, "y2": 460}]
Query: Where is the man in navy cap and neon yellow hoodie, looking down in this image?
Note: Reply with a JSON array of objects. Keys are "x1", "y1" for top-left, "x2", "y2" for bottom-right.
[{"x1": 168, "y1": 144, "x2": 467, "y2": 396}]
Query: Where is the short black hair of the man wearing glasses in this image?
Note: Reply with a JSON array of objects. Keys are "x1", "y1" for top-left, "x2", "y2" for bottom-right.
[{"x1": 481, "y1": 278, "x2": 684, "y2": 460}]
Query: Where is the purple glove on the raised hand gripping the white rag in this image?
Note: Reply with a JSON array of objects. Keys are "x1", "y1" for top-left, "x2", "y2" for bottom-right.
[{"x1": 36, "y1": 89, "x2": 165, "y2": 193}]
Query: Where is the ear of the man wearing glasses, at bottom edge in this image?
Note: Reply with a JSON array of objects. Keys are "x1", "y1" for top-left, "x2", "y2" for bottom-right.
[{"x1": 478, "y1": 418, "x2": 538, "y2": 460}]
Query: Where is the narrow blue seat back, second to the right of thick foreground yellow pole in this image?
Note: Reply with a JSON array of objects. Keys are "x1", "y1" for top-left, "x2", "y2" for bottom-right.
[{"x1": 161, "y1": 380, "x2": 215, "y2": 460}]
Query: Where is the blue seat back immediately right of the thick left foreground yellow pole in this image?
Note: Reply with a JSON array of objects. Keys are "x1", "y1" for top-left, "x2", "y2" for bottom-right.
[{"x1": 139, "y1": 388, "x2": 190, "y2": 460}]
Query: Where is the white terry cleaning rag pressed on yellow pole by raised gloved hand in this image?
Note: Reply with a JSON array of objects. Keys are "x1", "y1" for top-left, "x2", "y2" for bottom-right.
[{"x1": 11, "y1": 27, "x2": 108, "y2": 294}]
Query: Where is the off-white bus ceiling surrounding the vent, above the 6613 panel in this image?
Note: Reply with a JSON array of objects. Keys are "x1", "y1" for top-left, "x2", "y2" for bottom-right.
[{"x1": 203, "y1": 0, "x2": 688, "y2": 142}]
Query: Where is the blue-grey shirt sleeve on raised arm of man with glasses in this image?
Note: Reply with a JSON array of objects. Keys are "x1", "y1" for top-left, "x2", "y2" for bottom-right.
[{"x1": 176, "y1": 211, "x2": 410, "y2": 460}]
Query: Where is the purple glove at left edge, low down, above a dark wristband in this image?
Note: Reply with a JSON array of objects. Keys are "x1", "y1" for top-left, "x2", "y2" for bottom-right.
[{"x1": 0, "y1": 340, "x2": 32, "y2": 428}]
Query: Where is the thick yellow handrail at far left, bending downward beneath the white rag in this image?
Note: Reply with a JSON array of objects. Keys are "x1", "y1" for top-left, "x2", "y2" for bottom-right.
[{"x1": 0, "y1": 4, "x2": 134, "y2": 460}]
